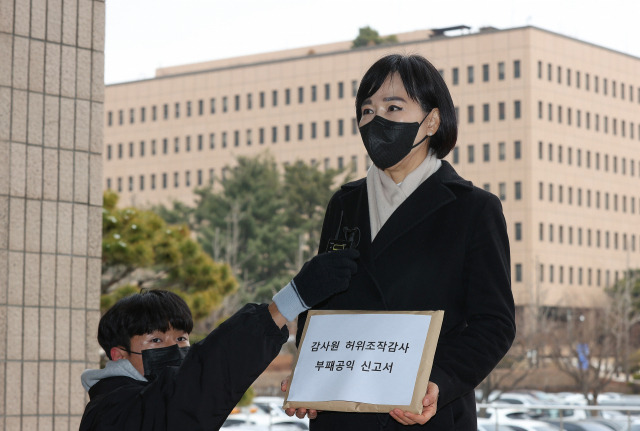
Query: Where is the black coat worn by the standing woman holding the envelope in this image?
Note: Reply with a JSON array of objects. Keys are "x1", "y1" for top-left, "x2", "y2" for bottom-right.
[{"x1": 298, "y1": 161, "x2": 515, "y2": 431}]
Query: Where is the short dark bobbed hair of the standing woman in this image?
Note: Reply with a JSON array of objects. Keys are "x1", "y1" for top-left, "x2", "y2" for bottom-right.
[{"x1": 356, "y1": 54, "x2": 458, "y2": 159}]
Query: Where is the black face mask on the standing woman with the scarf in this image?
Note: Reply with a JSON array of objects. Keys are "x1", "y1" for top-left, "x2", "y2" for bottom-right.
[{"x1": 360, "y1": 114, "x2": 428, "y2": 170}]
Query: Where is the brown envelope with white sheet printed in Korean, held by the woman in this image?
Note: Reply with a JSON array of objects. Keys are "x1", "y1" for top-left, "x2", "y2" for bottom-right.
[{"x1": 284, "y1": 311, "x2": 444, "y2": 413}]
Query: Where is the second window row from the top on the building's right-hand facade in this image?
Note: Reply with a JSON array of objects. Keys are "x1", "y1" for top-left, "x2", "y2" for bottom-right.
[{"x1": 538, "y1": 100, "x2": 640, "y2": 140}]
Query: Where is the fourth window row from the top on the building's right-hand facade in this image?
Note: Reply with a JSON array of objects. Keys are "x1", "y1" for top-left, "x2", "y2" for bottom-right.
[{"x1": 538, "y1": 181, "x2": 640, "y2": 214}]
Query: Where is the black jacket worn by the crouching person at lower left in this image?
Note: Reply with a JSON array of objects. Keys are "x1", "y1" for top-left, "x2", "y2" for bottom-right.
[{"x1": 80, "y1": 304, "x2": 288, "y2": 431}]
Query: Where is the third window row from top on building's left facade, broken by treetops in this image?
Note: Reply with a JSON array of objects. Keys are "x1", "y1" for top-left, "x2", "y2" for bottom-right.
[{"x1": 106, "y1": 155, "x2": 364, "y2": 193}]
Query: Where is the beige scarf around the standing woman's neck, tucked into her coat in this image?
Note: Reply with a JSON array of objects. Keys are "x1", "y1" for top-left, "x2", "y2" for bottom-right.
[{"x1": 367, "y1": 150, "x2": 442, "y2": 241}]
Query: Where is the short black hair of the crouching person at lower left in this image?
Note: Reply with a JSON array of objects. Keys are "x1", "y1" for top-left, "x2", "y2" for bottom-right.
[{"x1": 98, "y1": 289, "x2": 193, "y2": 359}]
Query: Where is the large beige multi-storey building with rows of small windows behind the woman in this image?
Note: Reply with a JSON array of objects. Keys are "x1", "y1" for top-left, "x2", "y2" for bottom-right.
[{"x1": 104, "y1": 27, "x2": 640, "y2": 307}]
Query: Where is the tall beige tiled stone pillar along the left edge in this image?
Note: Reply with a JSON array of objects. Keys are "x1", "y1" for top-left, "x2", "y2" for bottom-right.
[{"x1": 0, "y1": 0, "x2": 105, "y2": 430}]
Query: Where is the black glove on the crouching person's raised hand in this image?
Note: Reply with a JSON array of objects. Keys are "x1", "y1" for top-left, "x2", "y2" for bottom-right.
[{"x1": 293, "y1": 248, "x2": 360, "y2": 307}]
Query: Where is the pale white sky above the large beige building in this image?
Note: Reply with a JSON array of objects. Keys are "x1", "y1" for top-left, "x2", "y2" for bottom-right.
[{"x1": 105, "y1": 0, "x2": 640, "y2": 84}]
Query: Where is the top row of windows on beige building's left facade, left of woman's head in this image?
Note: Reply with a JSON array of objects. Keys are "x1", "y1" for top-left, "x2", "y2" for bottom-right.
[{"x1": 107, "y1": 80, "x2": 358, "y2": 127}]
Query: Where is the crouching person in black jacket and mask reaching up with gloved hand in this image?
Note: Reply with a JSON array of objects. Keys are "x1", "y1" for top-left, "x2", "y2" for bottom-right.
[{"x1": 80, "y1": 250, "x2": 358, "y2": 431}]
